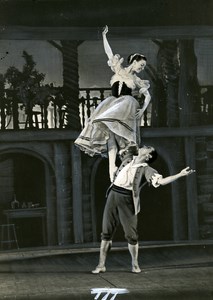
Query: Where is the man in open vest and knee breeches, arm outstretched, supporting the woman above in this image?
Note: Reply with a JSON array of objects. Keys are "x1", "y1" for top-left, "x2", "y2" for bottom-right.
[{"x1": 92, "y1": 146, "x2": 195, "y2": 274}]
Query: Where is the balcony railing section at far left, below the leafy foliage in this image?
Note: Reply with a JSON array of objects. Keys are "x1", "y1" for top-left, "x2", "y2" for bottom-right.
[{"x1": 0, "y1": 90, "x2": 66, "y2": 130}]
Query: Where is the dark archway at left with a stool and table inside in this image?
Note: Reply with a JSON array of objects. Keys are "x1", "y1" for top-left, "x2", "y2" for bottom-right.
[{"x1": 0, "y1": 152, "x2": 46, "y2": 248}]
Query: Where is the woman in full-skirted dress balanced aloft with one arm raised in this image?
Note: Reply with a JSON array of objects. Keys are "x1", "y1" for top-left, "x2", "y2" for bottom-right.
[{"x1": 75, "y1": 26, "x2": 151, "y2": 182}]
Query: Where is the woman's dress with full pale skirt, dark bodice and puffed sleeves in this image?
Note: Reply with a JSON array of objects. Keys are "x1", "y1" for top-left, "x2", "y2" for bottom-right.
[{"x1": 74, "y1": 54, "x2": 149, "y2": 157}]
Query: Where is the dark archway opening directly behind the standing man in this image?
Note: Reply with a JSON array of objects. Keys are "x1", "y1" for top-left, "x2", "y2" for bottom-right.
[{"x1": 92, "y1": 157, "x2": 173, "y2": 242}]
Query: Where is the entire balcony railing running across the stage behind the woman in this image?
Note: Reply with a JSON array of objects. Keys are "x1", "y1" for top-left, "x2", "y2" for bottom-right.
[{"x1": 0, "y1": 86, "x2": 213, "y2": 130}]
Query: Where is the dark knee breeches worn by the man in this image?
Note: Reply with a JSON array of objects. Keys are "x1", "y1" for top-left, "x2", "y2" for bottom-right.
[{"x1": 102, "y1": 188, "x2": 138, "y2": 245}]
